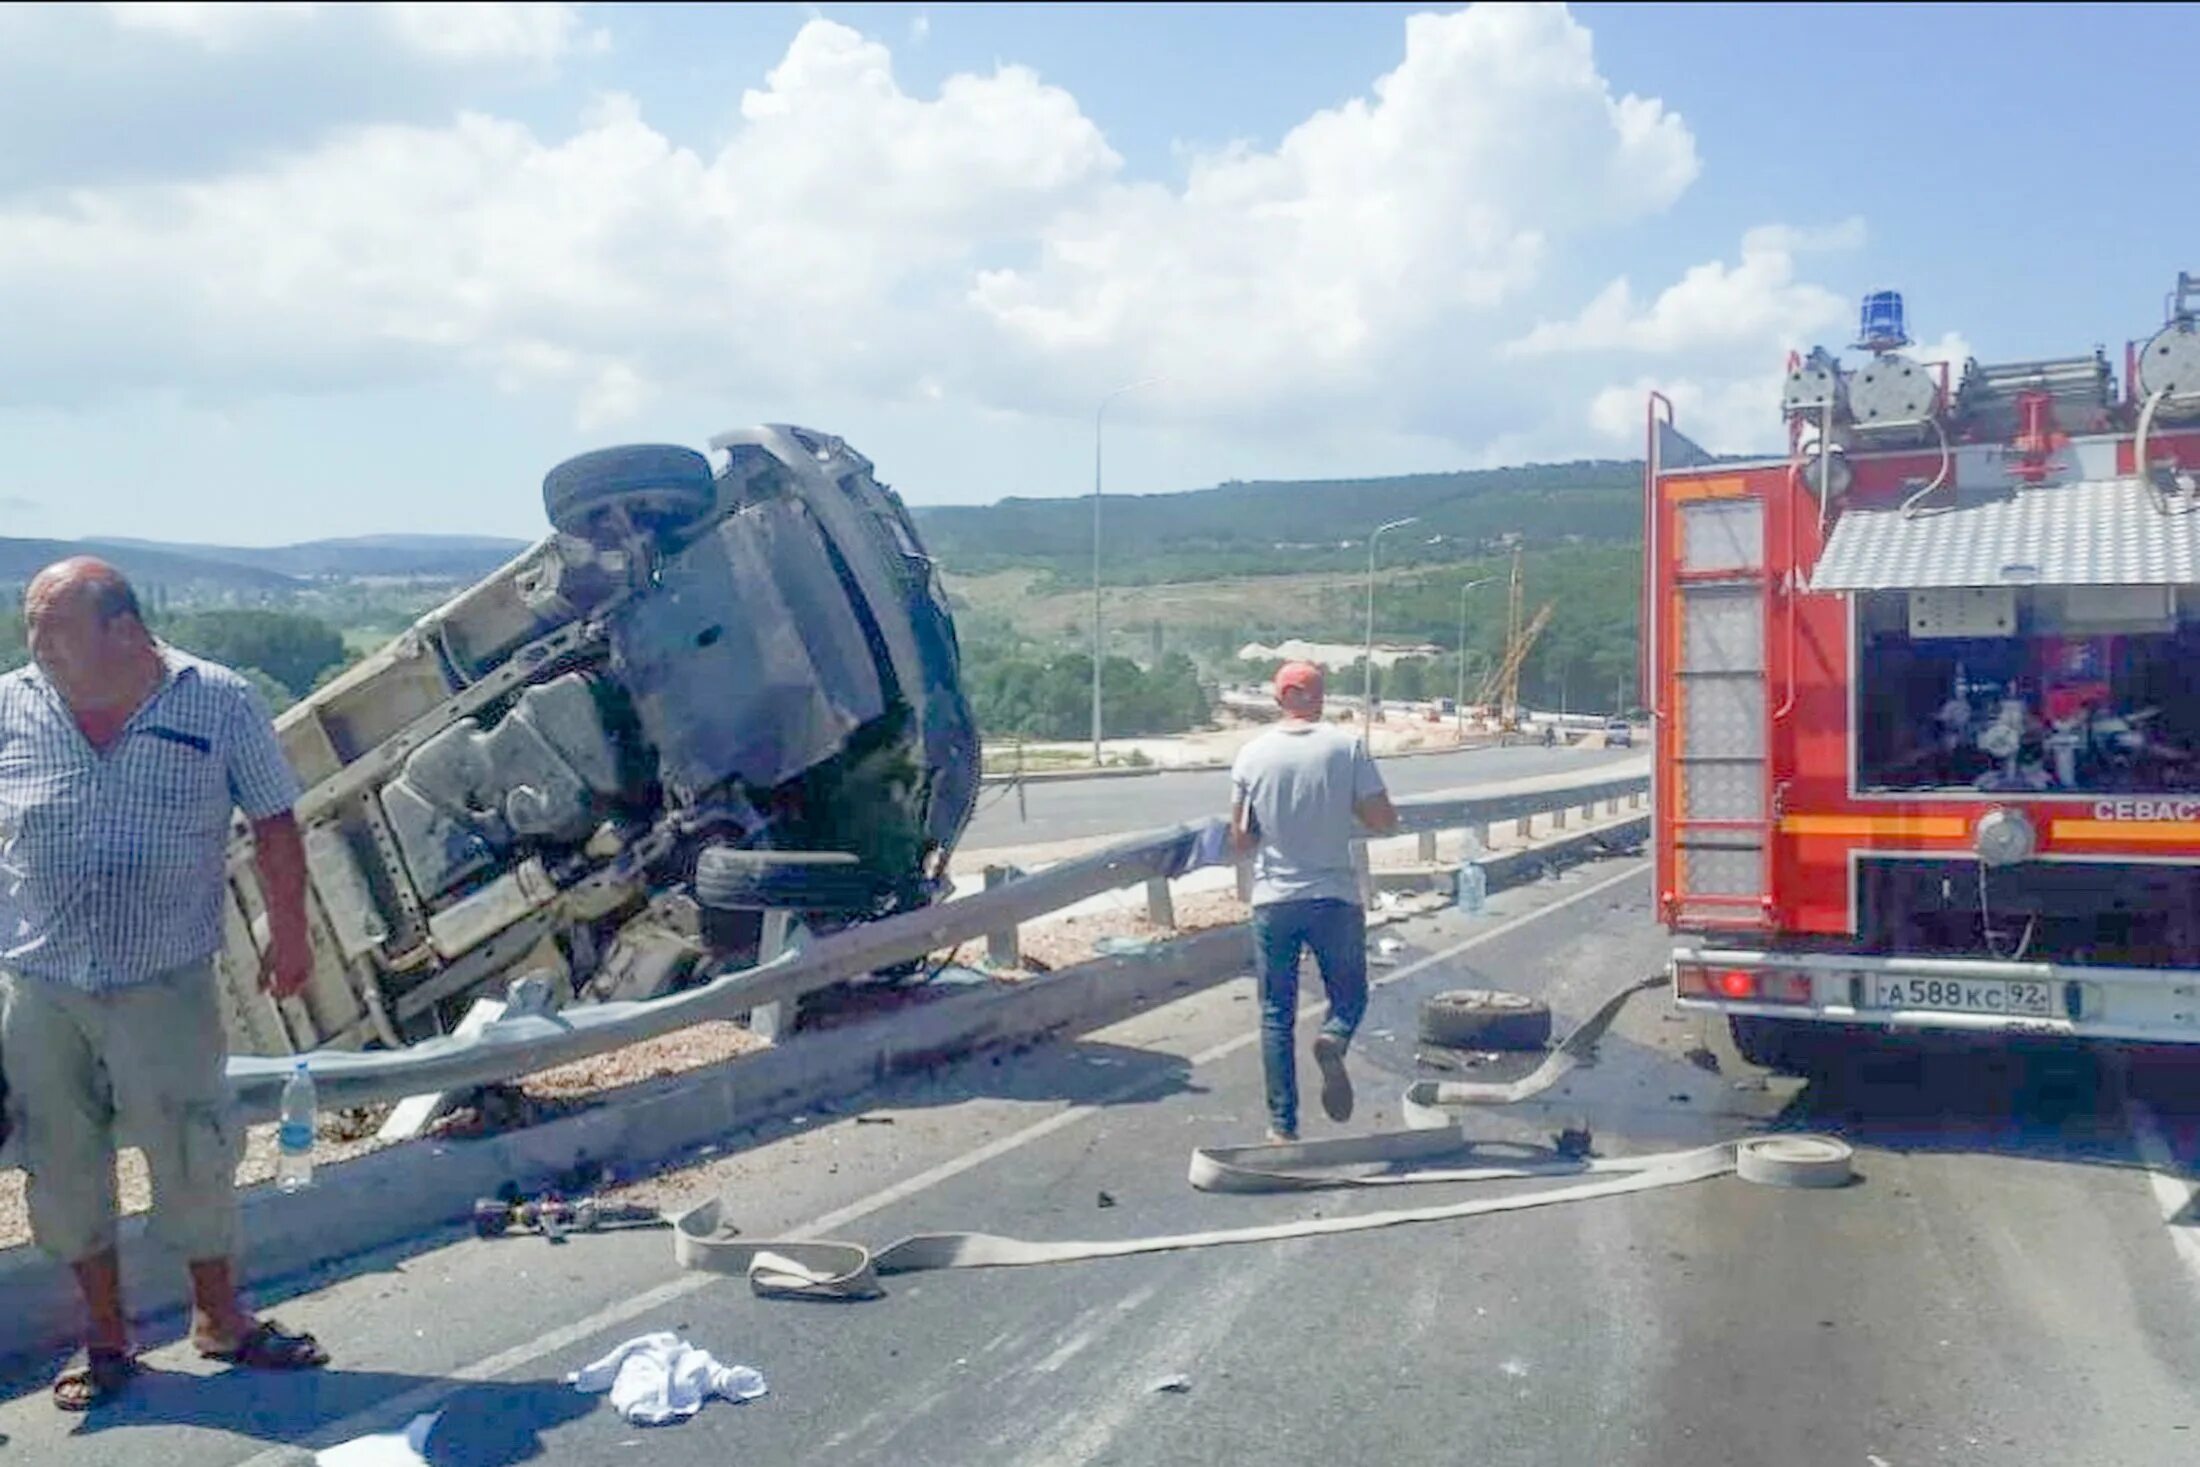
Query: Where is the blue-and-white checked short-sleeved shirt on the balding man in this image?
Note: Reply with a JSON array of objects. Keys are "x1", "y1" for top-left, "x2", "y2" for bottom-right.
[{"x1": 0, "y1": 647, "x2": 297, "y2": 992}]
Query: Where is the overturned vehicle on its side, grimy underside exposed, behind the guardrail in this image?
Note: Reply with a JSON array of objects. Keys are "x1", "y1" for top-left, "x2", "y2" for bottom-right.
[{"x1": 220, "y1": 427, "x2": 979, "y2": 1054}]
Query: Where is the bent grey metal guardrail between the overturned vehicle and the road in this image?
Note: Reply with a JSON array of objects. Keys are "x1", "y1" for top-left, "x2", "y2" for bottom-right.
[{"x1": 229, "y1": 776, "x2": 1650, "y2": 1122}]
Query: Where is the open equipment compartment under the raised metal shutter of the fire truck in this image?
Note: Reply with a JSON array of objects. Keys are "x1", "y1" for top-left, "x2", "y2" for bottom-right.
[{"x1": 1852, "y1": 585, "x2": 2200, "y2": 796}]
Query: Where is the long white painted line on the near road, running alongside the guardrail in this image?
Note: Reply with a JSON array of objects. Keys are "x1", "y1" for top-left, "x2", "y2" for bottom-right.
[{"x1": 238, "y1": 862, "x2": 1654, "y2": 1467}]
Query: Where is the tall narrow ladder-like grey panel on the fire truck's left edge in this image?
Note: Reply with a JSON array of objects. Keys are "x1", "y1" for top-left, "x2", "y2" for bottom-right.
[{"x1": 1650, "y1": 395, "x2": 1771, "y2": 930}]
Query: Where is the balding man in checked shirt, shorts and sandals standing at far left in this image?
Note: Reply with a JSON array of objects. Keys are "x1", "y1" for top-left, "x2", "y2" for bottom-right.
[{"x1": 0, "y1": 556, "x2": 328, "y2": 1410}]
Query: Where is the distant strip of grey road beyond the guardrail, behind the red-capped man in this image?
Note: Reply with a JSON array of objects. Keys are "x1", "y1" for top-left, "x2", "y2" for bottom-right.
[{"x1": 961, "y1": 746, "x2": 1641, "y2": 851}]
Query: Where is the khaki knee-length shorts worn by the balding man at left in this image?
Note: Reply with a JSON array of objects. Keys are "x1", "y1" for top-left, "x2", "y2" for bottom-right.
[{"x1": 0, "y1": 959, "x2": 242, "y2": 1262}]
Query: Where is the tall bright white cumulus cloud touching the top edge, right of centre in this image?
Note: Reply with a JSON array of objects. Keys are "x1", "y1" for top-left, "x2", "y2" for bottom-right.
[{"x1": 972, "y1": 4, "x2": 1698, "y2": 409}]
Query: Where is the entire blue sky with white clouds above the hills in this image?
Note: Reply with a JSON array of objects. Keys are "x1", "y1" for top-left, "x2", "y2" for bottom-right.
[{"x1": 0, "y1": 4, "x2": 2200, "y2": 543}]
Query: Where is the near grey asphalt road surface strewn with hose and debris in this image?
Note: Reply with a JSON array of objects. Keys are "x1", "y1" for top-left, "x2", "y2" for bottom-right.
[{"x1": 0, "y1": 860, "x2": 2200, "y2": 1467}]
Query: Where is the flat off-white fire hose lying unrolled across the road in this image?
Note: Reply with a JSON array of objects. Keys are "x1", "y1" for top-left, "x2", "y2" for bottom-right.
[{"x1": 673, "y1": 977, "x2": 1852, "y2": 1300}]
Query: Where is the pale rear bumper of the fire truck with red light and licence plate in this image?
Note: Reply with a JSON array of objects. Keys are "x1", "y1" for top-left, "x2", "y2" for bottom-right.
[{"x1": 1670, "y1": 944, "x2": 2200, "y2": 1045}]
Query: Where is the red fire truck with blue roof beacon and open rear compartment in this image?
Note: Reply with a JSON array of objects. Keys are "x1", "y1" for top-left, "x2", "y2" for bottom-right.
[{"x1": 1643, "y1": 275, "x2": 2200, "y2": 1067}]
